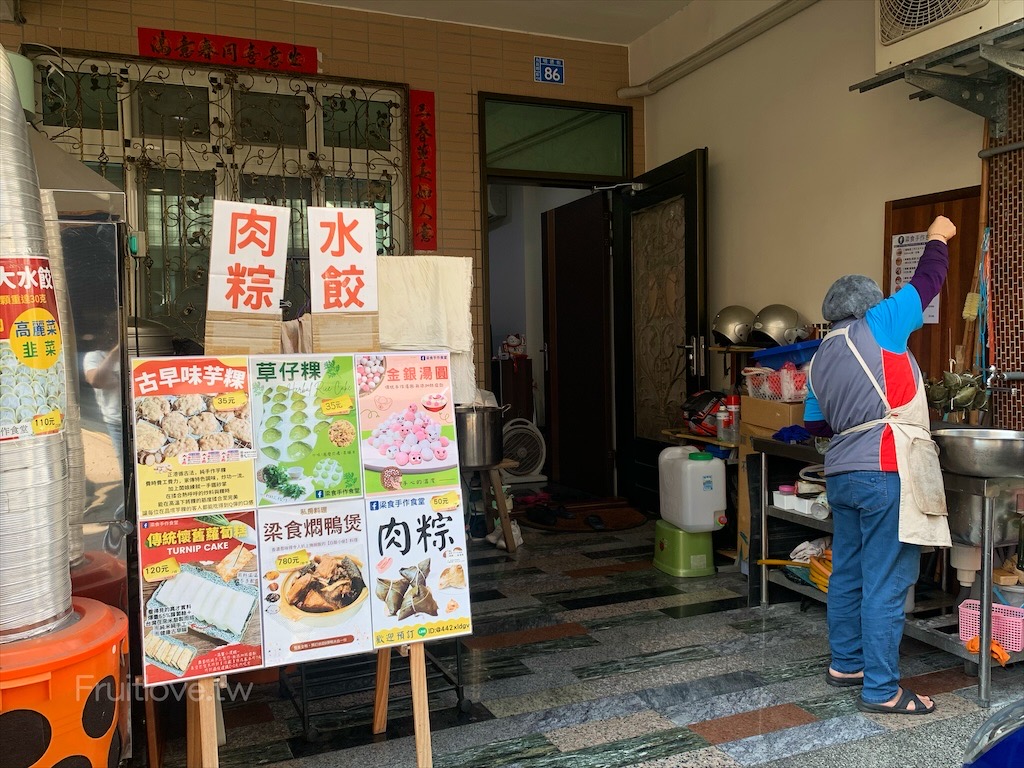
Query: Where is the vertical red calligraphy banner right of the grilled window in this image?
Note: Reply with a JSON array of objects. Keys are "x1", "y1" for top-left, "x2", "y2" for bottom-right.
[{"x1": 409, "y1": 90, "x2": 437, "y2": 251}]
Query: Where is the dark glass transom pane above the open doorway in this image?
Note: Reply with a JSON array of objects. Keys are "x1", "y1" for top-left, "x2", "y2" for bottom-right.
[{"x1": 484, "y1": 98, "x2": 629, "y2": 178}]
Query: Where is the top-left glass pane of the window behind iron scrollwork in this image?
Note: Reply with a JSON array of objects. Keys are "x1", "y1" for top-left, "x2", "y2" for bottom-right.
[{"x1": 43, "y1": 68, "x2": 118, "y2": 131}]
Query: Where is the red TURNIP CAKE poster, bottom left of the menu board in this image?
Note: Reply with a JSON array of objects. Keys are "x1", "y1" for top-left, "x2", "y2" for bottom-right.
[{"x1": 138, "y1": 511, "x2": 263, "y2": 685}]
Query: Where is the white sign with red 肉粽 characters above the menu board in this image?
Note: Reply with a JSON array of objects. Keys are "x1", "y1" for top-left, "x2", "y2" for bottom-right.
[{"x1": 207, "y1": 200, "x2": 292, "y2": 314}]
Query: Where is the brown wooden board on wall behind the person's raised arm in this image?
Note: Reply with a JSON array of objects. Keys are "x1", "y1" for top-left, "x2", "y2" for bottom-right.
[{"x1": 882, "y1": 186, "x2": 981, "y2": 379}]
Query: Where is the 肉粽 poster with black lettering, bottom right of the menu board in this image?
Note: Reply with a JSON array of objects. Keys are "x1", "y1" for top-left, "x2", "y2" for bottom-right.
[{"x1": 367, "y1": 489, "x2": 473, "y2": 648}]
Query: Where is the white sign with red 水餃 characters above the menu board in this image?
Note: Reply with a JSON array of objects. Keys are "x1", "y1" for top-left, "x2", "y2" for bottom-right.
[{"x1": 306, "y1": 208, "x2": 377, "y2": 313}]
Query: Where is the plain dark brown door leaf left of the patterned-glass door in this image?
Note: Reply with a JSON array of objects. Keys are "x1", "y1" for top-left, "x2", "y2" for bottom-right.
[{"x1": 542, "y1": 193, "x2": 614, "y2": 496}]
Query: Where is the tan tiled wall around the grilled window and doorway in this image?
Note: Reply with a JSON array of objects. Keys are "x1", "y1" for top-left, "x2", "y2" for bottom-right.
[{"x1": 0, "y1": 0, "x2": 644, "y2": 381}]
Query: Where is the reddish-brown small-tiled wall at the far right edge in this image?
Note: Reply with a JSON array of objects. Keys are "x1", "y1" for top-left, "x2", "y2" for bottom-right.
[{"x1": 988, "y1": 83, "x2": 1024, "y2": 429}]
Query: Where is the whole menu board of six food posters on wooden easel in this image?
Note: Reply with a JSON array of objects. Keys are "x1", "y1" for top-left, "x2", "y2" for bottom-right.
[{"x1": 131, "y1": 352, "x2": 472, "y2": 685}]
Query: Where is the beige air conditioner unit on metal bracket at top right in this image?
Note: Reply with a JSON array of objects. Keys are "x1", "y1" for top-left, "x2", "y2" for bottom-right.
[{"x1": 874, "y1": 0, "x2": 1024, "y2": 73}]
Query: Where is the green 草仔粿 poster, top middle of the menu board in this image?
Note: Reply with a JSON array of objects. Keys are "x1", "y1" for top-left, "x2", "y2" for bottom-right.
[{"x1": 249, "y1": 354, "x2": 362, "y2": 506}]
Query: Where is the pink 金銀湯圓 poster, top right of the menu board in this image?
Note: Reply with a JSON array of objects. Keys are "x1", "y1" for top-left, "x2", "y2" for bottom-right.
[{"x1": 355, "y1": 352, "x2": 459, "y2": 495}]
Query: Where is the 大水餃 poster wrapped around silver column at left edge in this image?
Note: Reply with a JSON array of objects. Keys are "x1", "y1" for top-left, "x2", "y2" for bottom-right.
[{"x1": 0, "y1": 257, "x2": 68, "y2": 440}]
